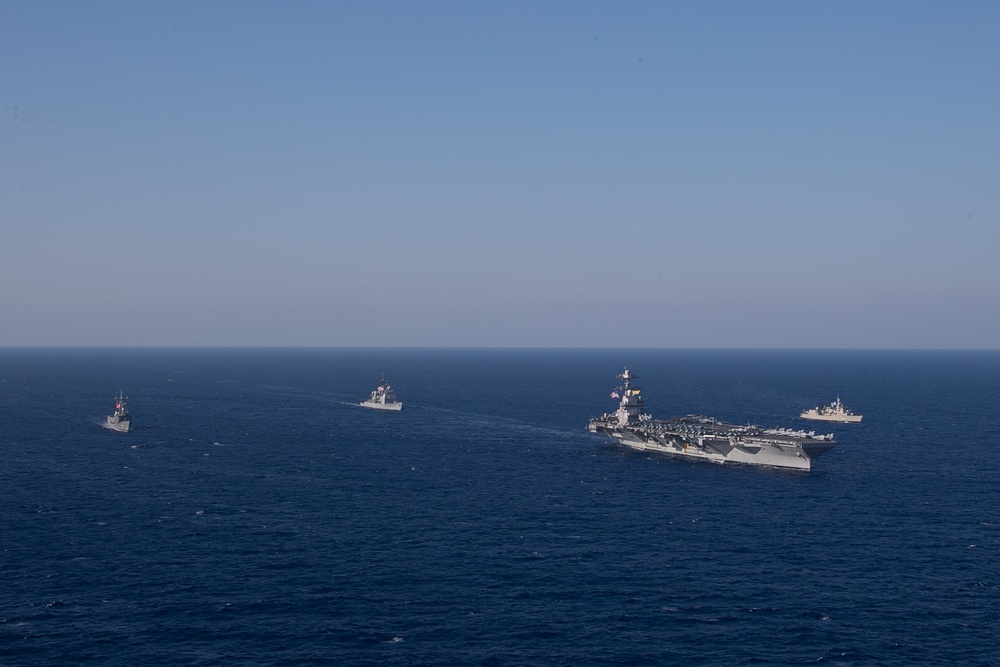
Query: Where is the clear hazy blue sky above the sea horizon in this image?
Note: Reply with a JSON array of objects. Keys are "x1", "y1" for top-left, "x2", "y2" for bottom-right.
[{"x1": 0, "y1": 0, "x2": 1000, "y2": 349}]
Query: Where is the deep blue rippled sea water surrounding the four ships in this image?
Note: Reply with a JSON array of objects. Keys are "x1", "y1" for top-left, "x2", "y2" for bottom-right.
[{"x1": 0, "y1": 349, "x2": 1000, "y2": 666}]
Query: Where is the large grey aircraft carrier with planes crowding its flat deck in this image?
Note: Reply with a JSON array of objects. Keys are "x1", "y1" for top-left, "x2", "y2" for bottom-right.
[{"x1": 587, "y1": 368, "x2": 837, "y2": 470}]
